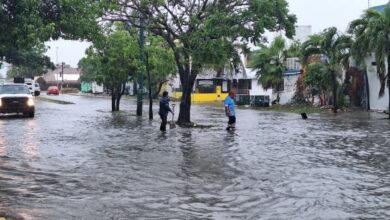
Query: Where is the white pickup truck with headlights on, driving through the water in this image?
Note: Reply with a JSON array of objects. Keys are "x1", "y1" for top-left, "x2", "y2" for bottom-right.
[{"x1": 0, "y1": 83, "x2": 35, "y2": 117}]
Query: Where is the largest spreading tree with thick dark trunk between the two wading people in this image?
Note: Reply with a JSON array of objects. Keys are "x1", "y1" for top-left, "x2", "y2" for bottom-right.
[{"x1": 106, "y1": 0, "x2": 296, "y2": 125}]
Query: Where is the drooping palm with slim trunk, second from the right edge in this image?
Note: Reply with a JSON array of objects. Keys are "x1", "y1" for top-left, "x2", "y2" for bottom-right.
[{"x1": 302, "y1": 27, "x2": 351, "y2": 113}]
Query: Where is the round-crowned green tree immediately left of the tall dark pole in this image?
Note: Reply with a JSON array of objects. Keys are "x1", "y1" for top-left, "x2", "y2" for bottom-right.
[{"x1": 80, "y1": 30, "x2": 141, "y2": 111}]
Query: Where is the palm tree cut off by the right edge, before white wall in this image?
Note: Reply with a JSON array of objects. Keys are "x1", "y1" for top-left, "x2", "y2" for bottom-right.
[{"x1": 350, "y1": 5, "x2": 390, "y2": 119}]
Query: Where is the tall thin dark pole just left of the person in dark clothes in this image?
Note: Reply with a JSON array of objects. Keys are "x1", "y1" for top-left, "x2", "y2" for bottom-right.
[{"x1": 137, "y1": 15, "x2": 145, "y2": 116}]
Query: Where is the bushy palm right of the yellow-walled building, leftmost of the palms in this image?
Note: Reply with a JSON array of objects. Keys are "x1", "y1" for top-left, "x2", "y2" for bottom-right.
[{"x1": 252, "y1": 36, "x2": 287, "y2": 100}]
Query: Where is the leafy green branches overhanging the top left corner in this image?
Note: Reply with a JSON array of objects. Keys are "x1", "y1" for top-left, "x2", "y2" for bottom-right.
[{"x1": 0, "y1": 0, "x2": 103, "y2": 64}]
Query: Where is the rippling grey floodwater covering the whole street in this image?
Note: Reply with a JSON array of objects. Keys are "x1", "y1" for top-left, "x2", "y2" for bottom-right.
[{"x1": 0, "y1": 96, "x2": 390, "y2": 219}]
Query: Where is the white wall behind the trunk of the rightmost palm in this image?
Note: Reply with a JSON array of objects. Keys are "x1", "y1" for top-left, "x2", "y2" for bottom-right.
[{"x1": 366, "y1": 54, "x2": 389, "y2": 111}]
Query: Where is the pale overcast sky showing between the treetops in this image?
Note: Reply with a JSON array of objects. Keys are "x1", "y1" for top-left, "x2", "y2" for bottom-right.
[{"x1": 42, "y1": 0, "x2": 388, "y2": 67}]
